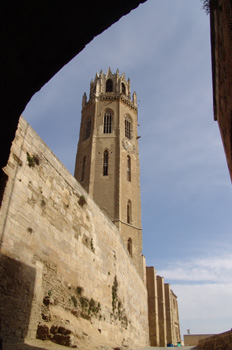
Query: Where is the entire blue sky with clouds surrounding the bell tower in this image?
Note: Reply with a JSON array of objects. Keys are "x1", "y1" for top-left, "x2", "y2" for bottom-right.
[{"x1": 23, "y1": 0, "x2": 232, "y2": 340}]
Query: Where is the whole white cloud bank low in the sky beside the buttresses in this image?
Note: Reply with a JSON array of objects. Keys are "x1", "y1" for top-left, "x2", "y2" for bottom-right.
[{"x1": 157, "y1": 252, "x2": 232, "y2": 334}]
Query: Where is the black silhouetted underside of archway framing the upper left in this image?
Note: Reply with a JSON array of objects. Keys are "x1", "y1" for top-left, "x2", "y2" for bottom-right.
[{"x1": 0, "y1": 0, "x2": 146, "y2": 169}]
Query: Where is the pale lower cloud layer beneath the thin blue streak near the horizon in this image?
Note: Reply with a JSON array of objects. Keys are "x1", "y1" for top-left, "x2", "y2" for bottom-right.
[{"x1": 172, "y1": 283, "x2": 232, "y2": 334}]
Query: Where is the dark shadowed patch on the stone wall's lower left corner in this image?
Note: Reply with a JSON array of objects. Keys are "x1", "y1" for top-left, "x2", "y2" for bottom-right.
[{"x1": 0, "y1": 253, "x2": 36, "y2": 347}]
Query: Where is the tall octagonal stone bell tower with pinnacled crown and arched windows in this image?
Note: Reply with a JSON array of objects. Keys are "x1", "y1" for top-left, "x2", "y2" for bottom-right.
[{"x1": 74, "y1": 68, "x2": 143, "y2": 278}]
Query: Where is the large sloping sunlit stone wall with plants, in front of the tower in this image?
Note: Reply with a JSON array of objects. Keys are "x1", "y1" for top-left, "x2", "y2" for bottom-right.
[{"x1": 0, "y1": 118, "x2": 149, "y2": 346}]
